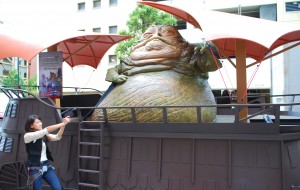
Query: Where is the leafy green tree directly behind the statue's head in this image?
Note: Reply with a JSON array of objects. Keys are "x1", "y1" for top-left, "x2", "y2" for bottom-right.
[{"x1": 115, "y1": 4, "x2": 177, "y2": 60}]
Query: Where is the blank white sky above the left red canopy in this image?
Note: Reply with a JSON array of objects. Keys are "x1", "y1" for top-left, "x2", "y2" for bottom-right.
[{"x1": 0, "y1": 0, "x2": 74, "y2": 28}]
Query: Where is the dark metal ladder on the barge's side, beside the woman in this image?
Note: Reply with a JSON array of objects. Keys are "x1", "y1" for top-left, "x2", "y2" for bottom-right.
[{"x1": 78, "y1": 121, "x2": 104, "y2": 190}]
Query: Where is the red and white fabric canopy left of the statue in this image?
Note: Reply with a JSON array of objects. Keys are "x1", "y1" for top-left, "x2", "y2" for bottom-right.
[{"x1": 0, "y1": 25, "x2": 131, "y2": 68}]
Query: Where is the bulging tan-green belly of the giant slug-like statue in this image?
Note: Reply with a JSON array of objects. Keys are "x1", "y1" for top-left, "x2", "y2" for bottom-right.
[{"x1": 91, "y1": 70, "x2": 216, "y2": 122}]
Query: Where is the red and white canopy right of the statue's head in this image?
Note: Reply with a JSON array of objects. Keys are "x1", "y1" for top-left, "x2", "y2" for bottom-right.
[{"x1": 138, "y1": 1, "x2": 300, "y2": 60}]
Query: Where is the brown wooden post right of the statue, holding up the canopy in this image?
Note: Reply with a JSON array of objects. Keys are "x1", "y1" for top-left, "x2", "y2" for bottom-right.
[{"x1": 235, "y1": 39, "x2": 248, "y2": 119}]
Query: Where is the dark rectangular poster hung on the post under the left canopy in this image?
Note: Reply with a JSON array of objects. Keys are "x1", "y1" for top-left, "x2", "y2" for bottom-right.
[{"x1": 39, "y1": 51, "x2": 62, "y2": 98}]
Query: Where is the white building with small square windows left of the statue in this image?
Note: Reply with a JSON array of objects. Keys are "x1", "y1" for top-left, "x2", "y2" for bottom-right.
[{"x1": 63, "y1": 0, "x2": 136, "y2": 91}]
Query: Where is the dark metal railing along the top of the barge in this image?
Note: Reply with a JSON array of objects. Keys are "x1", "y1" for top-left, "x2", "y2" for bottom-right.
[{"x1": 0, "y1": 87, "x2": 300, "y2": 134}]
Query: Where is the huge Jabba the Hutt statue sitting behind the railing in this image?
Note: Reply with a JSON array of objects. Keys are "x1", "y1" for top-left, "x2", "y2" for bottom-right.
[{"x1": 89, "y1": 25, "x2": 221, "y2": 122}]
